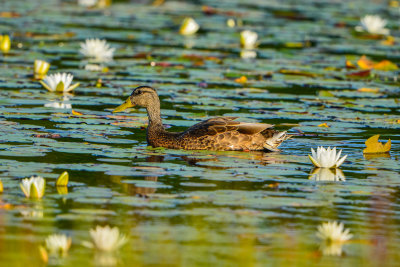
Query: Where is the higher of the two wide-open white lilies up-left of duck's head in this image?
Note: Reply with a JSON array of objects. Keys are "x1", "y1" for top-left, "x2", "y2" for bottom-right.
[{"x1": 79, "y1": 38, "x2": 115, "y2": 62}]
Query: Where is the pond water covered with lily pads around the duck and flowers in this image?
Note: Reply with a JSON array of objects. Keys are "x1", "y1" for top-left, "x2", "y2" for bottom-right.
[{"x1": 0, "y1": 0, "x2": 400, "y2": 266}]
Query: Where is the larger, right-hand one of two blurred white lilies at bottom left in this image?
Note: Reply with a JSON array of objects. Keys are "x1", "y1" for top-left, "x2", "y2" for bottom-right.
[{"x1": 82, "y1": 225, "x2": 128, "y2": 252}]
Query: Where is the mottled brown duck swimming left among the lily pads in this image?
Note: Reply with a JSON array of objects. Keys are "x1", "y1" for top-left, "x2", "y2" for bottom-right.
[{"x1": 113, "y1": 86, "x2": 289, "y2": 151}]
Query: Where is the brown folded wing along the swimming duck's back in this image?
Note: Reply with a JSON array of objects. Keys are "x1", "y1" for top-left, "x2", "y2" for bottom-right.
[{"x1": 182, "y1": 117, "x2": 273, "y2": 137}]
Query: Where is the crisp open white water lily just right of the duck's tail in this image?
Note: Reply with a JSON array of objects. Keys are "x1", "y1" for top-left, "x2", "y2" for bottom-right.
[{"x1": 308, "y1": 146, "x2": 347, "y2": 168}]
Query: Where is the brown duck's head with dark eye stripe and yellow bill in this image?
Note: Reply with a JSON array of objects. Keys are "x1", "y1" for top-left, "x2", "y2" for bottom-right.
[{"x1": 113, "y1": 86, "x2": 159, "y2": 112}]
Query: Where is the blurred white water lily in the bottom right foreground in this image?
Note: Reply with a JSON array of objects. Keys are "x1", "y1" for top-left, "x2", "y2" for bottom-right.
[{"x1": 316, "y1": 221, "x2": 353, "y2": 243}]
